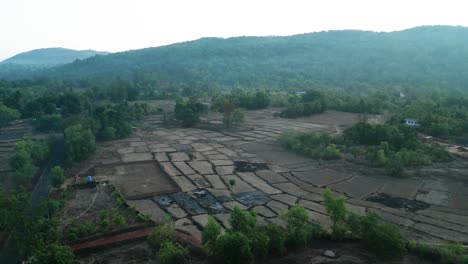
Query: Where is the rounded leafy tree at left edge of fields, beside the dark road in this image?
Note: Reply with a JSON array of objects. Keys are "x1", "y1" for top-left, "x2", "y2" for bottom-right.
[{"x1": 64, "y1": 125, "x2": 96, "y2": 162}]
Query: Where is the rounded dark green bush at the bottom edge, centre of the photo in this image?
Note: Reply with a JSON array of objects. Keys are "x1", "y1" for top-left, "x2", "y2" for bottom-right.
[{"x1": 215, "y1": 232, "x2": 251, "y2": 264}]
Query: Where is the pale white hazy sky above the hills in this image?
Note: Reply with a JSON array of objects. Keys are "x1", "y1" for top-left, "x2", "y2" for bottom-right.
[{"x1": 0, "y1": 0, "x2": 468, "y2": 60}]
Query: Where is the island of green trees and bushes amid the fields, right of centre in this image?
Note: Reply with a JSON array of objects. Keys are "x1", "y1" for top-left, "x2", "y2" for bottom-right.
[{"x1": 278, "y1": 120, "x2": 454, "y2": 177}]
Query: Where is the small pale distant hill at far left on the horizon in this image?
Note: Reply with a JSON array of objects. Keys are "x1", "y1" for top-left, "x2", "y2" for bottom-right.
[{"x1": 0, "y1": 48, "x2": 109, "y2": 67}]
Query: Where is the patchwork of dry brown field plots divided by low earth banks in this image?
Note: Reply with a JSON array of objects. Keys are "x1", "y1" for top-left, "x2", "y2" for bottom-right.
[{"x1": 69, "y1": 111, "x2": 468, "y2": 248}]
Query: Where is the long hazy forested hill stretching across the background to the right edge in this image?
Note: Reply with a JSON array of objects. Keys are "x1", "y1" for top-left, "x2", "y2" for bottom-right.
[{"x1": 4, "y1": 26, "x2": 468, "y2": 89}]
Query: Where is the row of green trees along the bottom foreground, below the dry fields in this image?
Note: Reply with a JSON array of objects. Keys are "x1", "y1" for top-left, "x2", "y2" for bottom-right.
[{"x1": 144, "y1": 189, "x2": 468, "y2": 264}]
